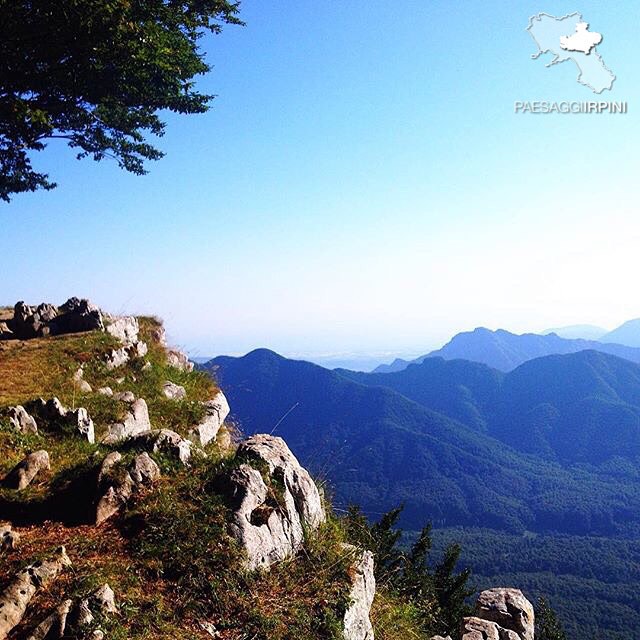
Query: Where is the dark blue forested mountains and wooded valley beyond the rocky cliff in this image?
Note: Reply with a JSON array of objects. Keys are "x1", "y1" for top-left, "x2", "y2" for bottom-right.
[{"x1": 207, "y1": 350, "x2": 640, "y2": 640}]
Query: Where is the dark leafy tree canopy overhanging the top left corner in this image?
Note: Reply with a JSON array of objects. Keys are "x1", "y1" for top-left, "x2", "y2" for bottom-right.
[{"x1": 0, "y1": 0, "x2": 242, "y2": 201}]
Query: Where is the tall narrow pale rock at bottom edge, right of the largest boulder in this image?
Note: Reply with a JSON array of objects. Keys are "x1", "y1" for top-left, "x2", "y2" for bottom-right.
[{"x1": 343, "y1": 545, "x2": 376, "y2": 640}]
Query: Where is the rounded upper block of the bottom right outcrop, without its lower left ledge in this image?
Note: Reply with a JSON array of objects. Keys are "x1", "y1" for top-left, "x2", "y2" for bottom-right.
[{"x1": 475, "y1": 588, "x2": 534, "y2": 640}]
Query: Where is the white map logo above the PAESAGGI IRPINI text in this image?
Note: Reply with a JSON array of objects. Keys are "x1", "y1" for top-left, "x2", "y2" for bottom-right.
[{"x1": 527, "y1": 13, "x2": 616, "y2": 94}]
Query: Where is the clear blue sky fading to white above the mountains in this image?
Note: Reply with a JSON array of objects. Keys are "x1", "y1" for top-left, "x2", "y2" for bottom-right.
[{"x1": 0, "y1": 0, "x2": 640, "y2": 355}]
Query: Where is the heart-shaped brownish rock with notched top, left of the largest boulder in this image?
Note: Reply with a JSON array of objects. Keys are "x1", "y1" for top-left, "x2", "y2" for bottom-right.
[{"x1": 96, "y1": 451, "x2": 160, "y2": 524}]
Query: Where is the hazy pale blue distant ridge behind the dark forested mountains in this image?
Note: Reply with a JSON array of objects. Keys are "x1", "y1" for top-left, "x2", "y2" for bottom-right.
[{"x1": 374, "y1": 327, "x2": 640, "y2": 373}]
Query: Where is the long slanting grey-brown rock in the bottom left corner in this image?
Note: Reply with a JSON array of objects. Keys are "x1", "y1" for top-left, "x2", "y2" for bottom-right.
[{"x1": 0, "y1": 547, "x2": 71, "y2": 640}]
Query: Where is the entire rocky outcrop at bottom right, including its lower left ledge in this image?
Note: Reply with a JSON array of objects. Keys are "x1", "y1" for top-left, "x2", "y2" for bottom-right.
[{"x1": 461, "y1": 588, "x2": 535, "y2": 640}]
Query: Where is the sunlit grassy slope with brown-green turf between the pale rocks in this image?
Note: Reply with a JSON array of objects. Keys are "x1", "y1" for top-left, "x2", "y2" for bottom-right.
[{"x1": 0, "y1": 318, "x2": 423, "y2": 640}]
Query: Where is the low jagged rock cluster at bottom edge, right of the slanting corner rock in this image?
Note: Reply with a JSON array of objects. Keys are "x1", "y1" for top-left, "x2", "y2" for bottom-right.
[{"x1": 27, "y1": 583, "x2": 118, "y2": 640}]
